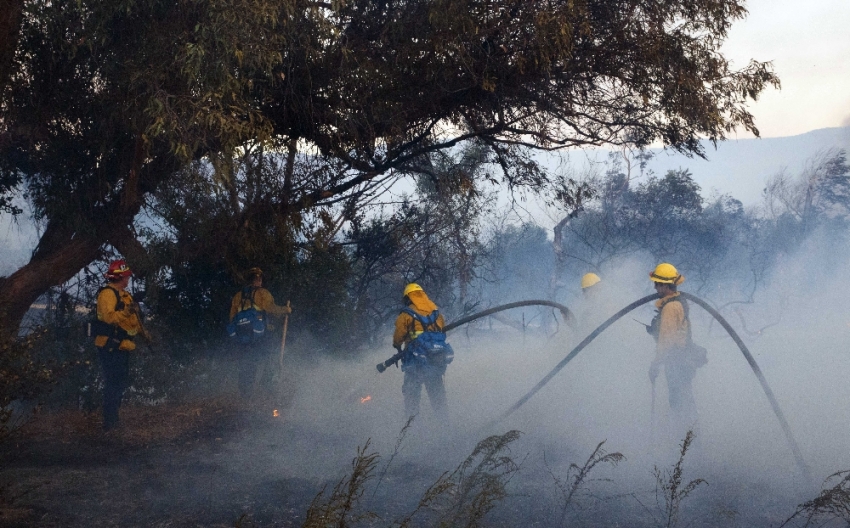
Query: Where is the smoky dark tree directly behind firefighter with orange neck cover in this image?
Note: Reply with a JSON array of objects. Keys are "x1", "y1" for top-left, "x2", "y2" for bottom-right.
[{"x1": 343, "y1": 142, "x2": 494, "y2": 344}]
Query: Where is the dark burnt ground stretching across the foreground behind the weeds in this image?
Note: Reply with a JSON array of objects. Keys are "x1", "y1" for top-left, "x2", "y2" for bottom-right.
[{"x1": 0, "y1": 336, "x2": 828, "y2": 528}]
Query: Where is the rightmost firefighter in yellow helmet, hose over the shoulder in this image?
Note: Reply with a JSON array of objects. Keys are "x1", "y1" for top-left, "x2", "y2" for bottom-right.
[{"x1": 647, "y1": 262, "x2": 704, "y2": 434}]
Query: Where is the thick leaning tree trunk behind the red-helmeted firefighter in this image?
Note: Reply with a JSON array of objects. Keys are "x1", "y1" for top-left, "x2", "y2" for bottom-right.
[{"x1": 0, "y1": 222, "x2": 101, "y2": 340}]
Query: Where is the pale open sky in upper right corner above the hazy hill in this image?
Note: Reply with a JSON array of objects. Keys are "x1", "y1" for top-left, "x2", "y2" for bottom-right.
[{"x1": 723, "y1": 0, "x2": 850, "y2": 137}]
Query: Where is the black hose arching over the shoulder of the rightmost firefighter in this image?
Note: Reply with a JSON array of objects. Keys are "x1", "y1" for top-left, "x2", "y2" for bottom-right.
[{"x1": 491, "y1": 292, "x2": 812, "y2": 482}]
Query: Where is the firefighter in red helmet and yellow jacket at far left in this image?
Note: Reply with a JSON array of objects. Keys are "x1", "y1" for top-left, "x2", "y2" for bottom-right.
[{"x1": 94, "y1": 260, "x2": 144, "y2": 431}]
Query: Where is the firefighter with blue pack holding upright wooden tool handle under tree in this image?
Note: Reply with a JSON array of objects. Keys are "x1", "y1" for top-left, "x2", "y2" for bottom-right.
[{"x1": 230, "y1": 267, "x2": 292, "y2": 399}]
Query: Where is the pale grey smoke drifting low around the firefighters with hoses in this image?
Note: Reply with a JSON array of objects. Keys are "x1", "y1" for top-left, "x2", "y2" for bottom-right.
[{"x1": 109, "y1": 224, "x2": 850, "y2": 526}]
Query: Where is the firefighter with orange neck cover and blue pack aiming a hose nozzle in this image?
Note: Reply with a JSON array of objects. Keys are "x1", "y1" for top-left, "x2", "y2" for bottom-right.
[{"x1": 393, "y1": 283, "x2": 453, "y2": 422}]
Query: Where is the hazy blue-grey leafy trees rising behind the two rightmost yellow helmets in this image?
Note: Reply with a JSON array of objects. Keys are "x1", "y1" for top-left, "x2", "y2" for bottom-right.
[{"x1": 548, "y1": 169, "x2": 746, "y2": 292}]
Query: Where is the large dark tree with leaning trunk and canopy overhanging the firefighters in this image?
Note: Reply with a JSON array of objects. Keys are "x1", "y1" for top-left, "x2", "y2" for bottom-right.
[{"x1": 0, "y1": 0, "x2": 778, "y2": 338}]
